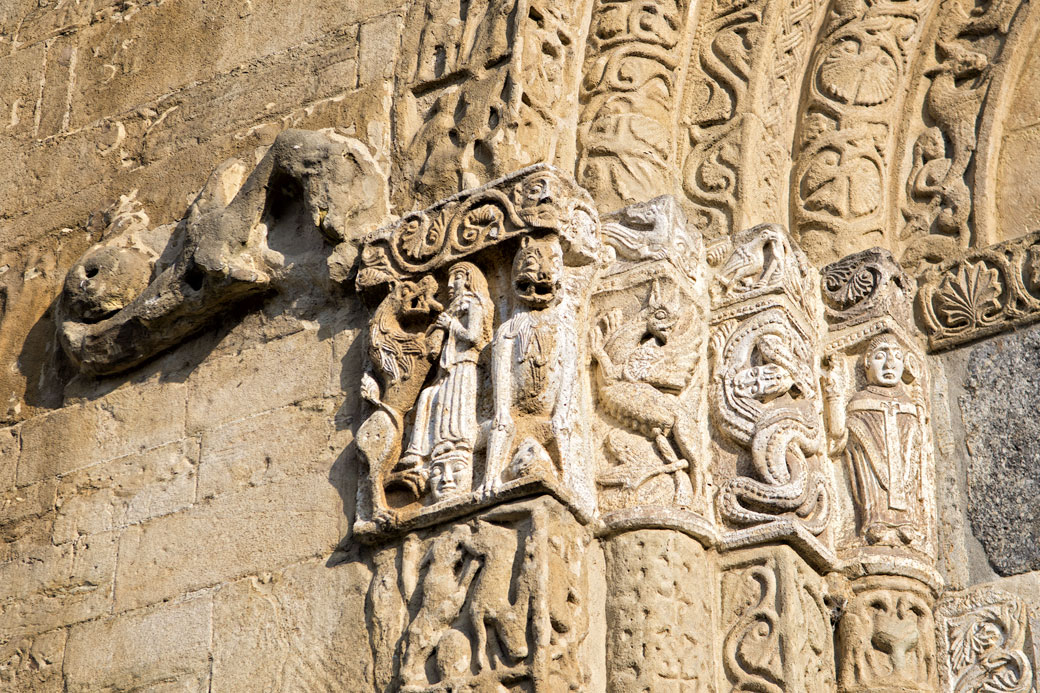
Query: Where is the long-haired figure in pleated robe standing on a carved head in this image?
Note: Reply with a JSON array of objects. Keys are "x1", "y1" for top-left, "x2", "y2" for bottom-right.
[{"x1": 399, "y1": 262, "x2": 494, "y2": 502}]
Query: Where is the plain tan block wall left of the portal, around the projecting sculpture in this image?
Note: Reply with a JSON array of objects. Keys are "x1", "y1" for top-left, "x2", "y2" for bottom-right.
[{"x1": 0, "y1": 0, "x2": 391, "y2": 691}]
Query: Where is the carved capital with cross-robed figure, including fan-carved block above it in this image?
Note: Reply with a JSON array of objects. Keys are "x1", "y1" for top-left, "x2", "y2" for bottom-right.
[{"x1": 822, "y1": 248, "x2": 936, "y2": 569}]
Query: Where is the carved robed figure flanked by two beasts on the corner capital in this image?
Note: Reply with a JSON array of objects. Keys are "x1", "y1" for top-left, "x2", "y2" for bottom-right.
[{"x1": 362, "y1": 236, "x2": 573, "y2": 516}]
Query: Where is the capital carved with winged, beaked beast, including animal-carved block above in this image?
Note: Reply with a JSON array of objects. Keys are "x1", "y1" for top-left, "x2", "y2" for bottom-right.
[{"x1": 589, "y1": 198, "x2": 707, "y2": 516}]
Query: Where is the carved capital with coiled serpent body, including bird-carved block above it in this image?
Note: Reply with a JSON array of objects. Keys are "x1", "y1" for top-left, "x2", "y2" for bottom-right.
[{"x1": 708, "y1": 224, "x2": 831, "y2": 535}]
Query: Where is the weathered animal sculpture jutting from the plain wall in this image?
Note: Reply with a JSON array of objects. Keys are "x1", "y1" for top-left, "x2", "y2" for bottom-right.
[{"x1": 58, "y1": 130, "x2": 389, "y2": 374}]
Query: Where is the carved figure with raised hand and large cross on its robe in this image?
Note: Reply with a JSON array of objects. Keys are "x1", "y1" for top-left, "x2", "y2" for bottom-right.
[{"x1": 828, "y1": 334, "x2": 925, "y2": 546}]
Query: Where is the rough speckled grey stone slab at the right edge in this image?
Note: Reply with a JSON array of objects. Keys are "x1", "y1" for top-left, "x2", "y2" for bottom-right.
[{"x1": 960, "y1": 329, "x2": 1040, "y2": 576}]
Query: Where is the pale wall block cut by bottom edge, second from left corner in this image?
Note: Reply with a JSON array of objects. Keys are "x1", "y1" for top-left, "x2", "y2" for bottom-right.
[{"x1": 64, "y1": 595, "x2": 212, "y2": 693}]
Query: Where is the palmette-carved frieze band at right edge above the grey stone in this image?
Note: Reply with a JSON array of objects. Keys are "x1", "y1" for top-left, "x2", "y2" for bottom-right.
[{"x1": 917, "y1": 232, "x2": 1040, "y2": 351}]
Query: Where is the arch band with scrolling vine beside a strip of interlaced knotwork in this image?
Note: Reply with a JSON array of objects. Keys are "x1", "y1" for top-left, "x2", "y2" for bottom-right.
[{"x1": 680, "y1": 0, "x2": 828, "y2": 237}]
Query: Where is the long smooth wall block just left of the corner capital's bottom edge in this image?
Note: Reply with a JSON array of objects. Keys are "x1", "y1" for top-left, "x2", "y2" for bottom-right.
[{"x1": 115, "y1": 474, "x2": 342, "y2": 611}]
